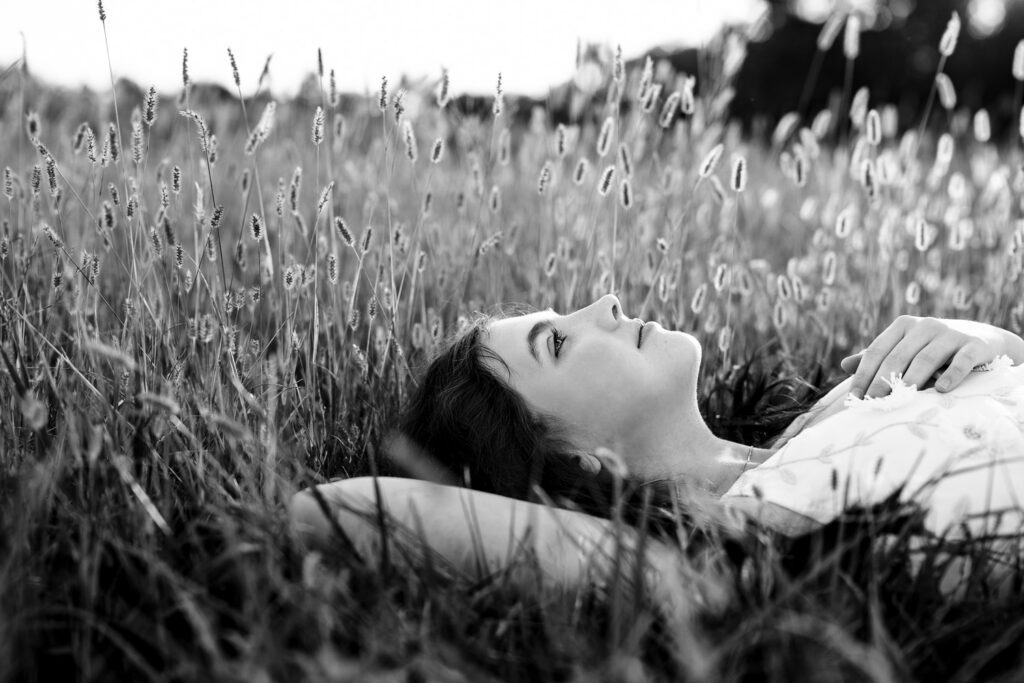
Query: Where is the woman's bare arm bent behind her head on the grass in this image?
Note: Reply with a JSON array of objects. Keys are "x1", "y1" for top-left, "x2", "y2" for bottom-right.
[{"x1": 289, "y1": 477, "x2": 675, "y2": 588}]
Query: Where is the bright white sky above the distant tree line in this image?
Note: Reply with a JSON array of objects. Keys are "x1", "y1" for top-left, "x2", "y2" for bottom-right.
[{"x1": 0, "y1": 0, "x2": 764, "y2": 95}]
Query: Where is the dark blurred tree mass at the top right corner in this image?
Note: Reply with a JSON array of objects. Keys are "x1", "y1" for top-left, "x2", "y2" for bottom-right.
[{"x1": 731, "y1": 0, "x2": 1024, "y2": 133}]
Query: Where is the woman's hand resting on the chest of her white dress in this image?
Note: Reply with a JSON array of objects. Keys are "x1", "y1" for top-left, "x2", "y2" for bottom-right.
[{"x1": 840, "y1": 315, "x2": 1024, "y2": 398}]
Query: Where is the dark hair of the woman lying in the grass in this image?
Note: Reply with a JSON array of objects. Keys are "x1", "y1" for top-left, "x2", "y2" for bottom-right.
[{"x1": 400, "y1": 317, "x2": 704, "y2": 538}]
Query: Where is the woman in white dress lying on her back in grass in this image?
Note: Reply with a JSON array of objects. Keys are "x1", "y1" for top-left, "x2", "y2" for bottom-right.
[{"x1": 292, "y1": 296, "x2": 1024, "y2": 602}]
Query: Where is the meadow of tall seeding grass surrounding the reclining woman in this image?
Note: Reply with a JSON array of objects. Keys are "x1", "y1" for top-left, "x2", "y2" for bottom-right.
[{"x1": 6, "y1": 6, "x2": 1024, "y2": 681}]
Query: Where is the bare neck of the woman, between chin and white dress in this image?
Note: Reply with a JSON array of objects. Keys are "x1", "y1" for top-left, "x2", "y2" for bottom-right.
[{"x1": 622, "y1": 401, "x2": 771, "y2": 496}]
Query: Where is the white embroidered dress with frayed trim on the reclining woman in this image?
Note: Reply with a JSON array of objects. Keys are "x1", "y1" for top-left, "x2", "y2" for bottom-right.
[{"x1": 725, "y1": 356, "x2": 1024, "y2": 539}]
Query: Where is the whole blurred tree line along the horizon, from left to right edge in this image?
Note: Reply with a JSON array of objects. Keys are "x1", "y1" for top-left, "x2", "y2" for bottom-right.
[{"x1": 0, "y1": 0, "x2": 1024, "y2": 147}]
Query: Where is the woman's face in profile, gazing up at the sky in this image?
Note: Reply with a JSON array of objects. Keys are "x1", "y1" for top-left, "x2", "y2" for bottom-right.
[{"x1": 483, "y1": 295, "x2": 700, "y2": 449}]
